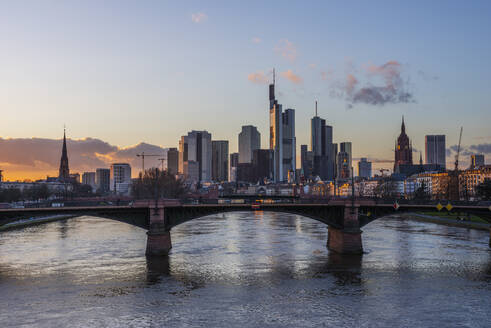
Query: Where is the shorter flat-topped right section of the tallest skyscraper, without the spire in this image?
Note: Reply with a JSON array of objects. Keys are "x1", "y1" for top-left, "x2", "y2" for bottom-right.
[{"x1": 281, "y1": 108, "x2": 297, "y2": 181}]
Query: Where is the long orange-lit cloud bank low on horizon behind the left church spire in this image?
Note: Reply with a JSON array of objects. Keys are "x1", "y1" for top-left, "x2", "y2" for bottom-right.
[{"x1": 0, "y1": 138, "x2": 169, "y2": 179}]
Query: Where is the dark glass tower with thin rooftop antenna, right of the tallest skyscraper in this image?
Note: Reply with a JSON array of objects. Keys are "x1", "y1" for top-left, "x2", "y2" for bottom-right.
[{"x1": 310, "y1": 101, "x2": 336, "y2": 180}]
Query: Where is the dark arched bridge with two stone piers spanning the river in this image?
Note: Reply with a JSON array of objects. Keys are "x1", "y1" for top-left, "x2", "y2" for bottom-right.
[{"x1": 0, "y1": 199, "x2": 491, "y2": 256}]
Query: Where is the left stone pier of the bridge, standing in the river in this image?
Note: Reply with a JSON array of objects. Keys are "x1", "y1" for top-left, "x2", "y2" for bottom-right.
[{"x1": 145, "y1": 206, "x2": 172, "y2": 256}]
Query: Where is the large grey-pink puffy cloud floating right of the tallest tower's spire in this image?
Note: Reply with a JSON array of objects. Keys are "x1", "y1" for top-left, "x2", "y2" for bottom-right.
[{"x1": 330, "y1": 60, "x2": 414, "y2": 108}]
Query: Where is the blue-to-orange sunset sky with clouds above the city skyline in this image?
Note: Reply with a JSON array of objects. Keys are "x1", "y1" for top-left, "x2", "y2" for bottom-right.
[{"x1": 0, "y1": 0, "x2": 491, "y2": 180}]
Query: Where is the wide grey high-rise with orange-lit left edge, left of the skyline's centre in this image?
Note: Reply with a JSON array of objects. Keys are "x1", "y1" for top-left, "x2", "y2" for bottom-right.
[{"x1": 179, "y1": 130, "x2": 212, "y2": 182}]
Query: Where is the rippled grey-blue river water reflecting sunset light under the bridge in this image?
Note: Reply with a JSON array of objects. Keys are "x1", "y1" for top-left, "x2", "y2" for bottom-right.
[{"x1": 0, "y1": 212, "x2": 491, "y2": 327}]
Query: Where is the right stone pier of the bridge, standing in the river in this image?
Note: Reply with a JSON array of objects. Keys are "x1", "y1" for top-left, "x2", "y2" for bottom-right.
[{"x1": 327, "y1": 206, "x2": 363, "y2": 254}]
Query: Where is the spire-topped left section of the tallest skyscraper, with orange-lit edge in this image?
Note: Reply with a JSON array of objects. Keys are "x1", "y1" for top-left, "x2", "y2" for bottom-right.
[{"x1": 269, "y1": 70, "x2": 284, "y2": 182}]
